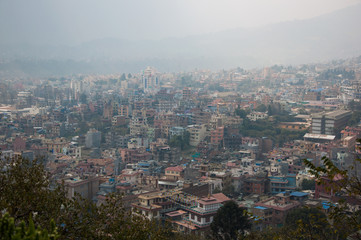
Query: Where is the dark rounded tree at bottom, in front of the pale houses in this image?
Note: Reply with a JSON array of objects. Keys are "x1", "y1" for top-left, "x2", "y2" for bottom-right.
[{"x1": 211, "y1": 201, "x2": 251, "y2": 240}]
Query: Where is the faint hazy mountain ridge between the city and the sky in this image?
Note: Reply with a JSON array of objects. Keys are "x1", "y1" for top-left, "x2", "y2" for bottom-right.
[{"x1": 0, "y1": 4, "x2": 361, "y2": 75}]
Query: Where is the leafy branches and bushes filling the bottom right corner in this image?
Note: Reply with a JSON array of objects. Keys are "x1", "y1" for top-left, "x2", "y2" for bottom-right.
[{"x1": 247, "y1": 151, "x2": 361, "y2": 240}]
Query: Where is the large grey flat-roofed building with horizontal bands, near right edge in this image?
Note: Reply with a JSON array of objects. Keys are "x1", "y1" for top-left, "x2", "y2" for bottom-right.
[{"x1": 311, "y1": 110, "x2": 352, "y2": 135}]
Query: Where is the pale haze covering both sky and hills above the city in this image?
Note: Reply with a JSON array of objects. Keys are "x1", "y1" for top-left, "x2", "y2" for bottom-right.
[{"x1": 0, "y1": 0, "x2": 361, "y2": 74}]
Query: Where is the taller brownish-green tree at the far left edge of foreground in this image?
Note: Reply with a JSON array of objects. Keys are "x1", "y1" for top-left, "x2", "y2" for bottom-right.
[{"x1": 0, "y1": 157, "x2": 66, "y2": 229}]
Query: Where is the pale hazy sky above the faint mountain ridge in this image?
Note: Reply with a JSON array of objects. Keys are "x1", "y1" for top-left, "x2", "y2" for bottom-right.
[{"x1": 0, "y1": 0, "x2": 360, "y2": 44}]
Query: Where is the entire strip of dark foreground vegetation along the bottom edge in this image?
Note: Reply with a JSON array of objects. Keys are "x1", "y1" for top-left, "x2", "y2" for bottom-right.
[{"x1": 4, "y1": 152, "x2": 361, "y2": 240}]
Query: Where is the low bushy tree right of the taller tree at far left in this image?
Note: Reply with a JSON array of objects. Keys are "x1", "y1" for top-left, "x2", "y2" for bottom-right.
[{"x1": 59, "y1": 194, "x2": 171, "y2": 240}]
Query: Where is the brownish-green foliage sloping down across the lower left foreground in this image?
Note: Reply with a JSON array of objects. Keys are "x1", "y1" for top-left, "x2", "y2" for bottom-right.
[{"x1": 0, "y1": 157, "x2": 191, "y2": 239}]
